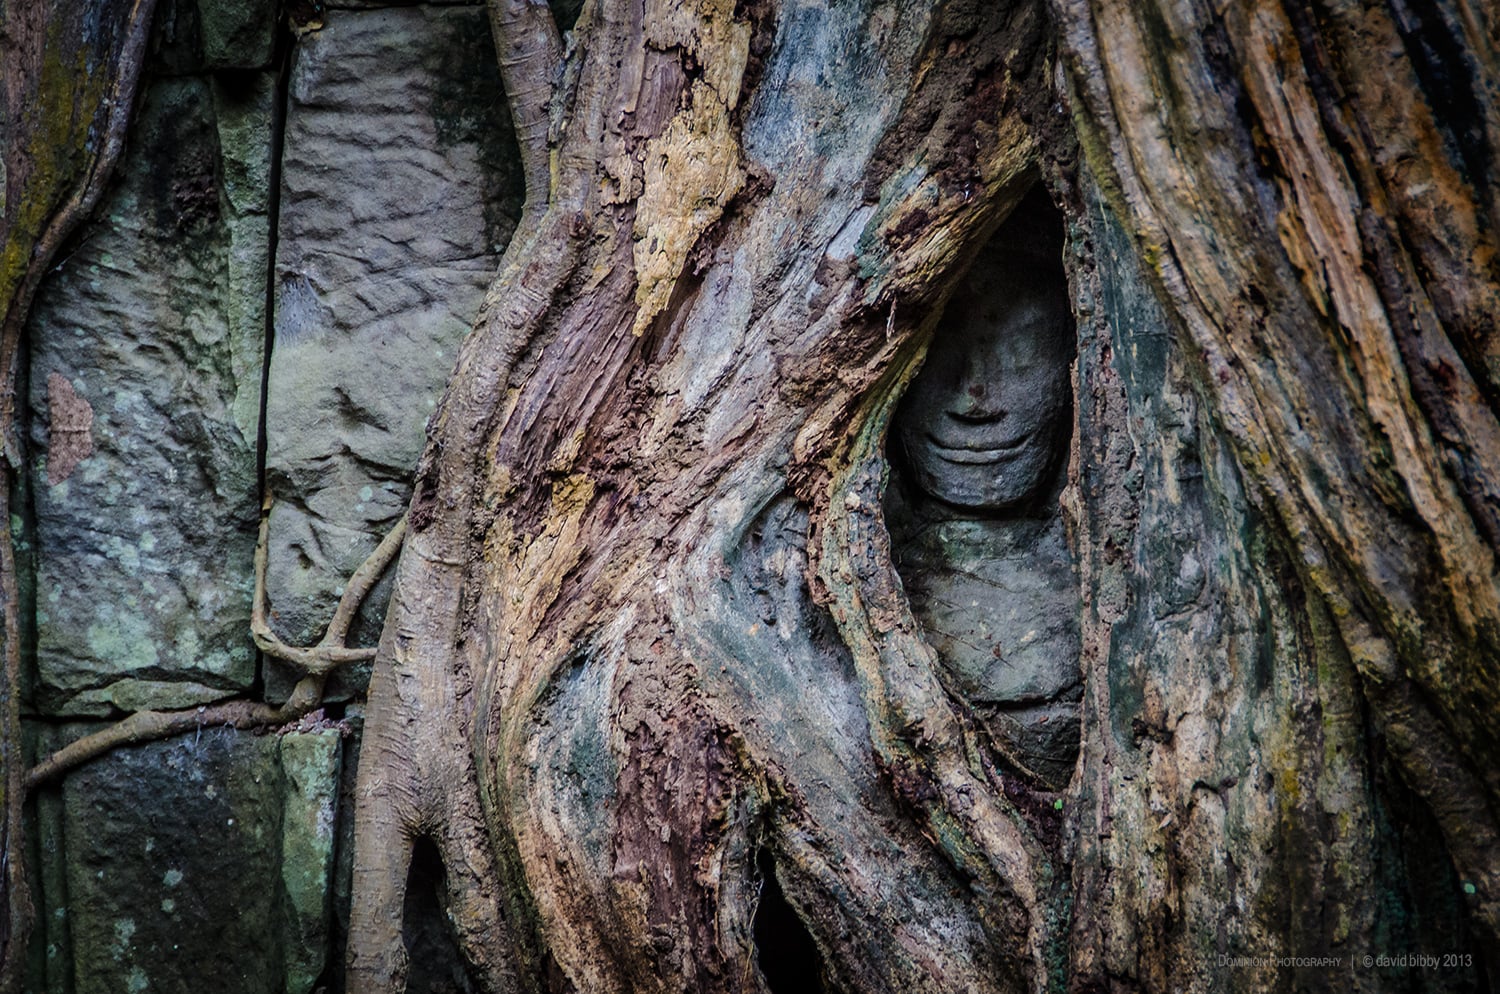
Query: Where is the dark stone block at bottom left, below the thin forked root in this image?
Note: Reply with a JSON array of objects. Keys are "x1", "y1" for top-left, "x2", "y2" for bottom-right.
[{"x1": 32, "y1": 726, "x2": 342, "y2": 994}]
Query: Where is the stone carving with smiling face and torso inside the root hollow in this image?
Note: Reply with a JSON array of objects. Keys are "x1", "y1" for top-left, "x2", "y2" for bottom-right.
[{"x1": 887, "y1": 225, "x2": 1082, "y2": 790}]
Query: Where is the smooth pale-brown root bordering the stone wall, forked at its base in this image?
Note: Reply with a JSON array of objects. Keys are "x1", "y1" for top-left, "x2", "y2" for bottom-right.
[{"x1": 347, "y1": 0, "x2": 578, "y2": 994}]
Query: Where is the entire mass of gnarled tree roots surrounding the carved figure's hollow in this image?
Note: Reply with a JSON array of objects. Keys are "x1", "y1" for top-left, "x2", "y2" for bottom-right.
[{"x1": 340, "y1": 0, "x2": 1500, "y2": 991}]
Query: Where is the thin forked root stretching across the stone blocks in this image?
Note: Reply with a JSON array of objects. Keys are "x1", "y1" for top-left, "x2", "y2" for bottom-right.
[{"x1": 26, "y1": 490, "x2": 407, "y2": 790}]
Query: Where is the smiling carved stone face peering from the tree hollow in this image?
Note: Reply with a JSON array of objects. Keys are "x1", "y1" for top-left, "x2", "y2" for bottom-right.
[{"x1": 893, "y1": 255, "x2": 1073, "y2": 513}]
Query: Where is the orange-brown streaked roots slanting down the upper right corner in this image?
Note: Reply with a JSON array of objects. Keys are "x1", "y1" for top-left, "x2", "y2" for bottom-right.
[{"x1": 1058, "y1": 0, "x2": 1500, "y2": 959}]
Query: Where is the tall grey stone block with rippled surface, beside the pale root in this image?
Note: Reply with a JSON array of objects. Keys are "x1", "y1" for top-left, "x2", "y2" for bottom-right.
[{"x1": 266, "y1": 6, "x2": 521, "y2": 697}]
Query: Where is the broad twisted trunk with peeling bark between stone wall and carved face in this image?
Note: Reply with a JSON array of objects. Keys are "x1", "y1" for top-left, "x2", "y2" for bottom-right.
[{"x1": 350, "y1": 3, "x2": 1053, "y2": 991}]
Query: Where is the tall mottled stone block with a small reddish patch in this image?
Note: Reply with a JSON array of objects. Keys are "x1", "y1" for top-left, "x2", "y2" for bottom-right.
[{"x1": 30, "y1": 75, "x2": 273, "y2": 715}]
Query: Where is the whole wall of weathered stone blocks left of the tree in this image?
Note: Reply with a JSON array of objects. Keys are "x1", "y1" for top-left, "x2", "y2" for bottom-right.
[{"x1": 14, "y1": 0, "x2": 521, "y2": 994}]
